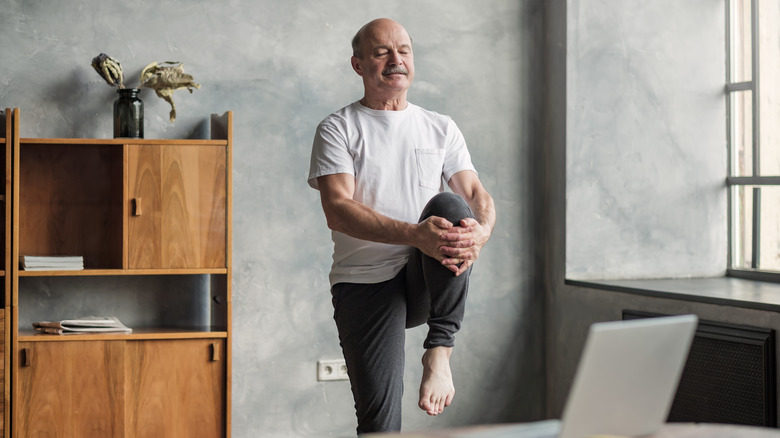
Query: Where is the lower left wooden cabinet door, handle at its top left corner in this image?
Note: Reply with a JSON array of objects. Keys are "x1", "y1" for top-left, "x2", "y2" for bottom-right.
[{"x1": 13, "y1": 341, "x2": 125, "y2": 438}]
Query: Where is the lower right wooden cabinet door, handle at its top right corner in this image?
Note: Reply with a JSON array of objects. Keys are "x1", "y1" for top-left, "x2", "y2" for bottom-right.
[{"x1": 126, "y1": 339, "x2": 226, "y2": 438}]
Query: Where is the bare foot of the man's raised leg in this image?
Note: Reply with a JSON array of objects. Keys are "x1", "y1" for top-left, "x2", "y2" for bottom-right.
[{"x1": 419, "y1": 347, "x2": 455, "y2": 415}]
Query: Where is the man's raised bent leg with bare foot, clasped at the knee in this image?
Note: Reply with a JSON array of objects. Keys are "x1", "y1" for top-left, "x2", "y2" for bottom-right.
[{"x1": 406, "y1": 192, "x2": 474, "y2": 415}]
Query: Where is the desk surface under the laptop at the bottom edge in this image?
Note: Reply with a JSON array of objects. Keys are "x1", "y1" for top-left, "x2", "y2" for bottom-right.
[{"x1": 366, "y1": 423, "x2": 780, "y2": 438}]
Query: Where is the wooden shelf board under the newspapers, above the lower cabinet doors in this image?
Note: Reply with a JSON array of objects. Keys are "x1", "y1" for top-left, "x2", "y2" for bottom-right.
[{"x1": 19, "y1": 327, "x2": 227, "y2": 342}]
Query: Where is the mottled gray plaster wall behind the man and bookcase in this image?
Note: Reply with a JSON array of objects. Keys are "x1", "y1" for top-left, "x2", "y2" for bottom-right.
[{"x1": 0, "y1": 0, "x2": 548, "y2": 438}]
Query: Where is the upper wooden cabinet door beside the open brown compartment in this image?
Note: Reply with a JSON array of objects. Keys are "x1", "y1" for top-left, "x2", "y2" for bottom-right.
[{"x1": 127, "y1": 145, "x2": 227, "y2": 269}]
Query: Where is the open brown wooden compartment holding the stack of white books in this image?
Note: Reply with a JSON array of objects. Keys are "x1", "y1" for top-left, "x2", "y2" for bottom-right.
[{"x1": 18, "y1": 142, "x2": 123, "y2": 269}]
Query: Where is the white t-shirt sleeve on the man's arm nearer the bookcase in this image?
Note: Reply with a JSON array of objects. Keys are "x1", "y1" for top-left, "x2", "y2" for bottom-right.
[{"x1": 308, "y1": 117, "x2": 355, "y2": 189}]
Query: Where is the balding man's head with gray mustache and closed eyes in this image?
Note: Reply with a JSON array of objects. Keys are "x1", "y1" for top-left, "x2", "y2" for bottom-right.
[{"x1": 352, "y1": 21, "x2": 414, "y2": 97}]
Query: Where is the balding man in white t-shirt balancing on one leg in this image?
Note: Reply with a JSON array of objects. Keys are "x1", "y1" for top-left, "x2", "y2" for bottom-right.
[{"x1": 308, "y1": 19, "x2": 495, "y2": 434}]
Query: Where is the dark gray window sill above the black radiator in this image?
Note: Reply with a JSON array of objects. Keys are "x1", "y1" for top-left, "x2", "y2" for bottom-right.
[{"x1": 566, "y1": 277, "x2": 780, "y2": 312}]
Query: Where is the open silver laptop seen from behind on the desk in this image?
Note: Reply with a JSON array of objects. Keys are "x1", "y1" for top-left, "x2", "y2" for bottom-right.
[{"x1": 460, "y1": 315, "x2": 698, "y2": 438}]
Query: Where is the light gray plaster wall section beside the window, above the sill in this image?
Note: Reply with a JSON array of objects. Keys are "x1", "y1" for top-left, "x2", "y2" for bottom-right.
[{"x1": 566, "y1": 0, "x2": 727, "y2": 279}]
